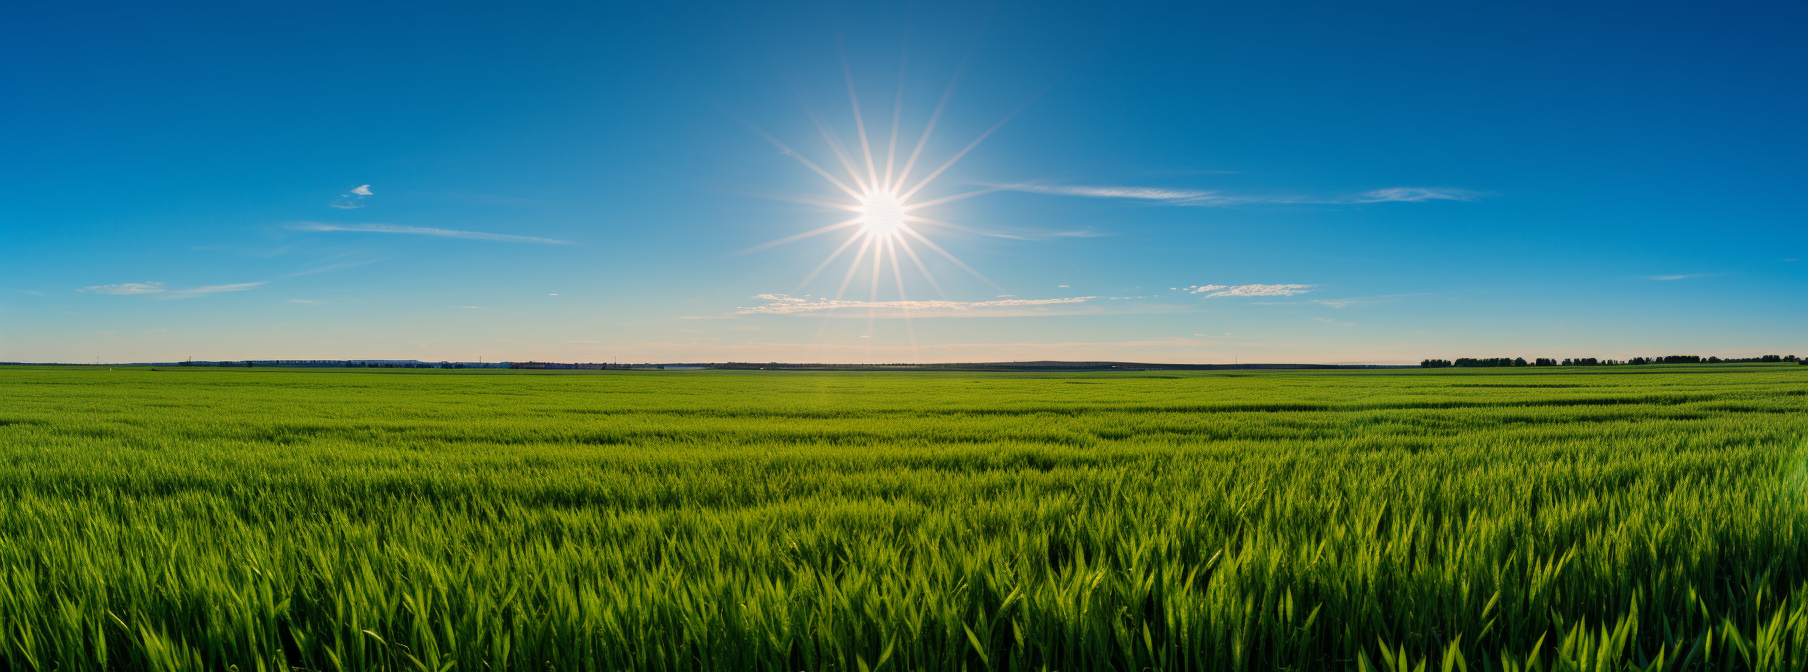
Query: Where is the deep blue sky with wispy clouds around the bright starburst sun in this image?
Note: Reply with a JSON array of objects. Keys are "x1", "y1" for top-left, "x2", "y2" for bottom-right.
[{"x1": 0, "y1": 2, "x2": 1808, "y2": 363}]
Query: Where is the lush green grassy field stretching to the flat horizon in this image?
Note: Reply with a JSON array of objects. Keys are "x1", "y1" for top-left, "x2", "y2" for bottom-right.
[{"x1": 0, "y1": 365, "x2": 1808, "y2": 672}]
